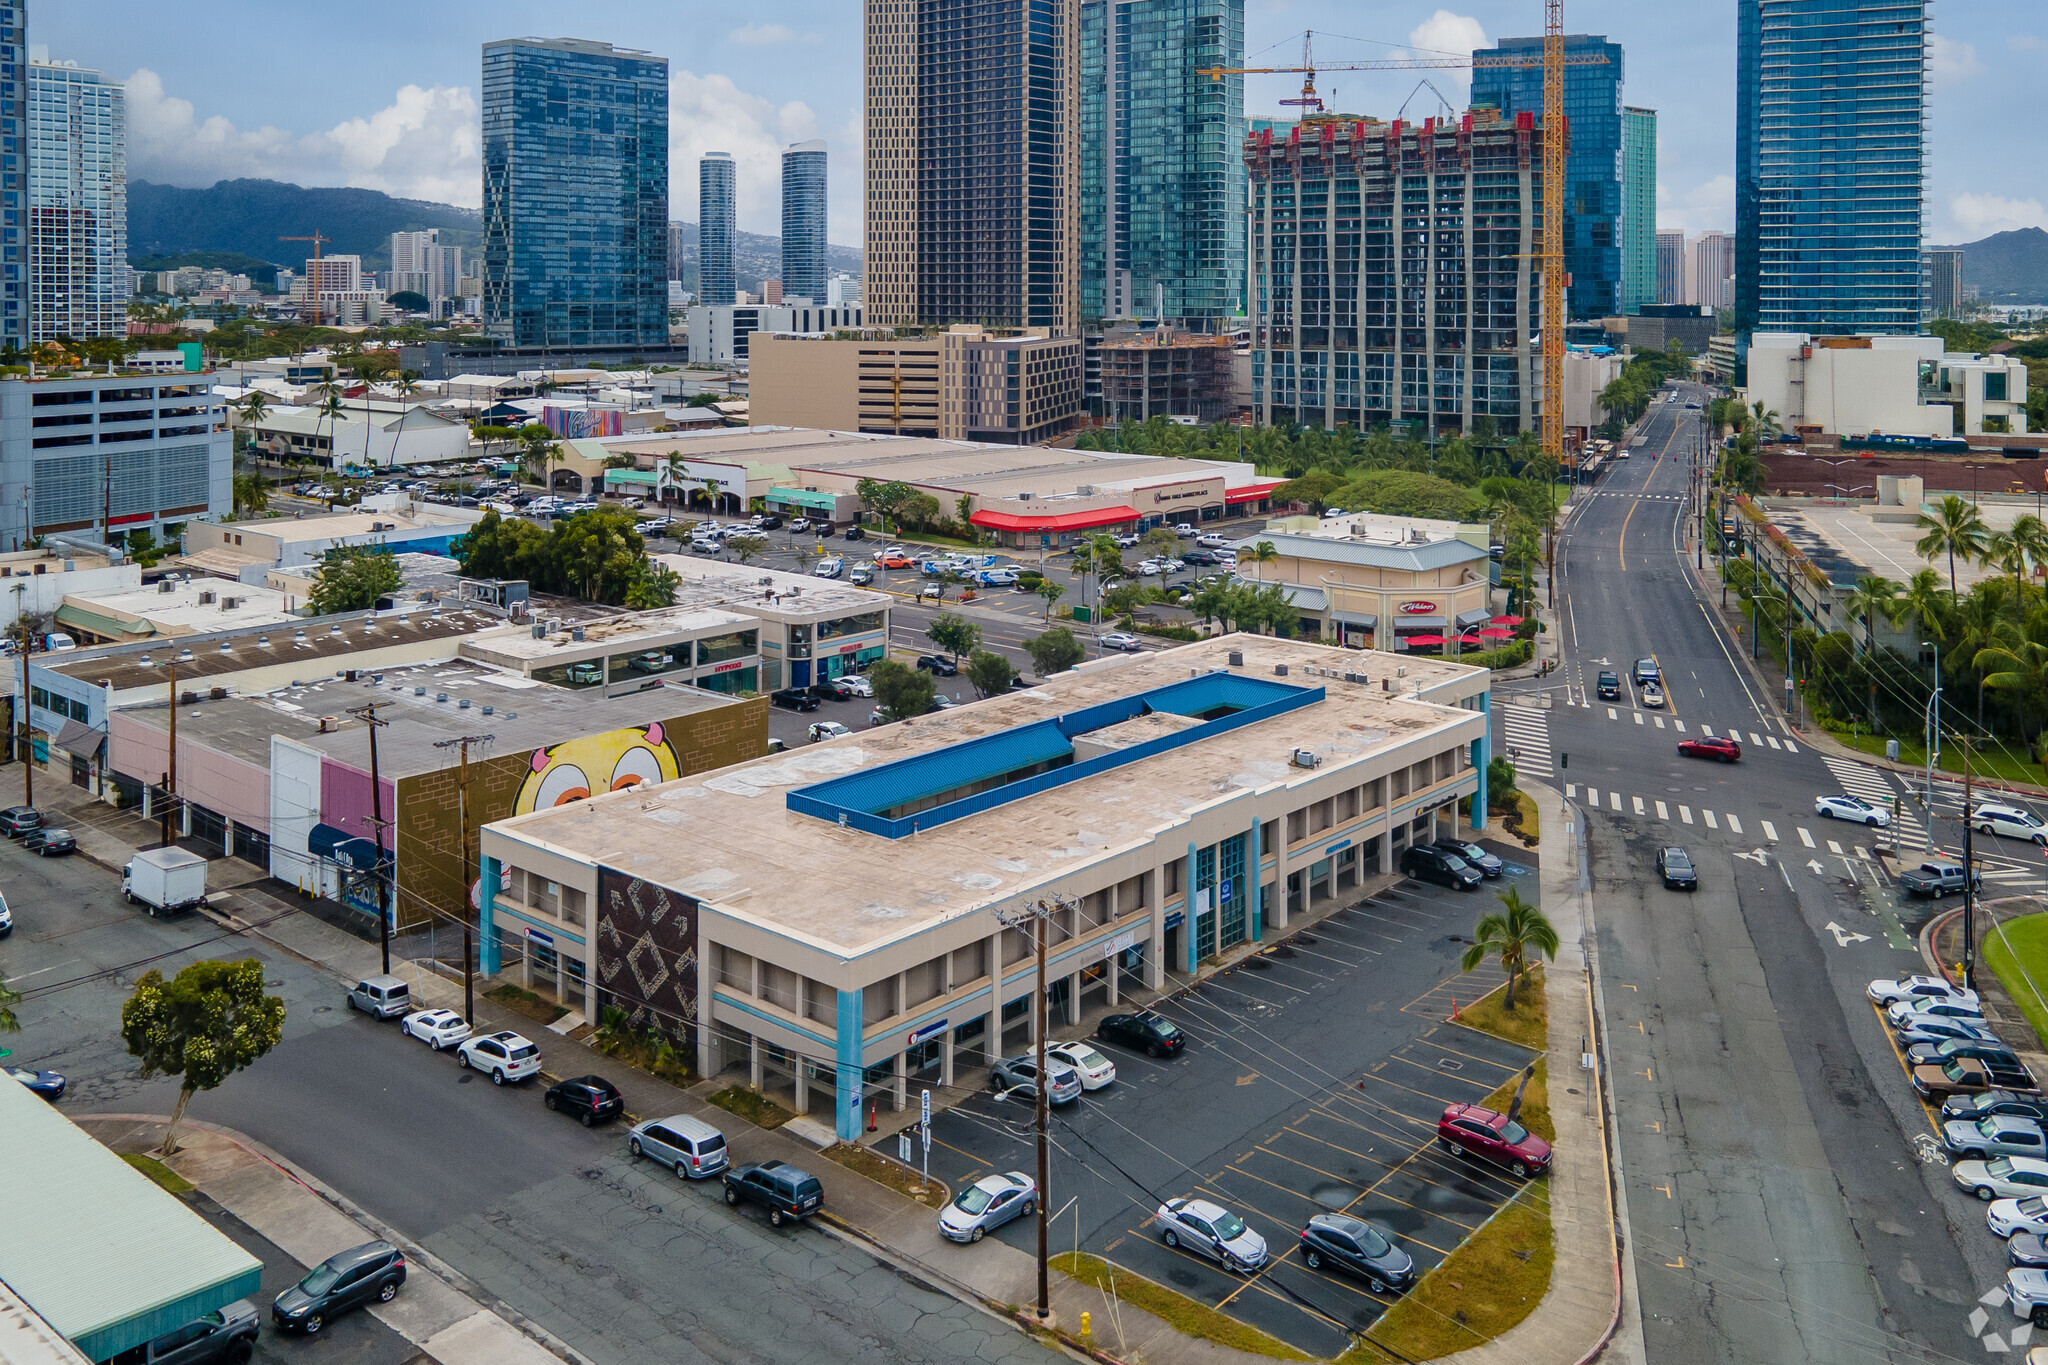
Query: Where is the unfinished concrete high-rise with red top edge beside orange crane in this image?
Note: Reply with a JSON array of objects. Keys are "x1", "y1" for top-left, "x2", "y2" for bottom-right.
[{"x1": 1245, "y1": 108, "x2": 1542, "y2": 434}]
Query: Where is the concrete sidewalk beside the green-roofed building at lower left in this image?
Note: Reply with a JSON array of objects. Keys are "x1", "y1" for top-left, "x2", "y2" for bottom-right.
[{"x1": 78, "y1": 1113, "x2": 582, "y2": 1365}]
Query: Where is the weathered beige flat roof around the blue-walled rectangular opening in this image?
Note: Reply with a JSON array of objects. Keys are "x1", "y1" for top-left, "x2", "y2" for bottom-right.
[{"x1": 492, "y1": 634, "x2": 1485, "y2": 956}]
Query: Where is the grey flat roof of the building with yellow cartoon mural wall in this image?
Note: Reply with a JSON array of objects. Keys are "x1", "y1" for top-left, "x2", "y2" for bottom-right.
[{"x1": 119, "y1": 657, "x2": 735, "y2": 778}]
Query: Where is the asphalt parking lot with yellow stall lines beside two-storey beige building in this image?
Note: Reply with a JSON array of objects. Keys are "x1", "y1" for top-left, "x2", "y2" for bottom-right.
[{"x1": 879, "y1": 863, "x2": 1536, "y2": 1359}]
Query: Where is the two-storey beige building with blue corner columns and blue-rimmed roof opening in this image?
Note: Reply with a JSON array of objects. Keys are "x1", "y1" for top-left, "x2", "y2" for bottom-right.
[{"x1": 479, "y1": 636, "x2": 1489, "y2": 1140}]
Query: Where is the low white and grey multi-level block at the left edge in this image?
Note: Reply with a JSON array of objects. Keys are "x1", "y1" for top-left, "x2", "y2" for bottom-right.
[{"x1": 0, "y1": 372, "x2": 233, "y2": 551}]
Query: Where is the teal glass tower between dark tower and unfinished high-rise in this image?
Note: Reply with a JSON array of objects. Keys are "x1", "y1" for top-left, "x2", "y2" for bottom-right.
[{"x1": 1079, "y1": 0, "x2": 1245, "y2": 332}]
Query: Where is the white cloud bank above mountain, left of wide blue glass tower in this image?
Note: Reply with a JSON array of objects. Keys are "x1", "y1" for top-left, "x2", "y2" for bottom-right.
[{"x1": 127, "y1": 68, "x2": 481, "y2": 207}]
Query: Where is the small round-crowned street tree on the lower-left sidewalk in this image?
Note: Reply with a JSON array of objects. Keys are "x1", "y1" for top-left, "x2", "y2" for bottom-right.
[{"x1": 121, "y1": 958, "x2": 285, "y2": 1156}]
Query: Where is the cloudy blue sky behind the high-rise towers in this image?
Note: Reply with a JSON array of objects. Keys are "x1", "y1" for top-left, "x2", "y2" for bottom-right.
[{"x1": 29, "y1": 0, "x2": 2048, "y2": 246}]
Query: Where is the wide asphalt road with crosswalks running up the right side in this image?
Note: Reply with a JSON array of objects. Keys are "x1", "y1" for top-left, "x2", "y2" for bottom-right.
[{"x1": 1531, "y1": 391, "x2": 2017, "y2": 1363}]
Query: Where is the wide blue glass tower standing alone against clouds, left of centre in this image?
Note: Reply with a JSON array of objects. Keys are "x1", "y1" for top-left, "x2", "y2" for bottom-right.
[{"x1": 483, "y1": 39, "x2": 668, "y2": 348}]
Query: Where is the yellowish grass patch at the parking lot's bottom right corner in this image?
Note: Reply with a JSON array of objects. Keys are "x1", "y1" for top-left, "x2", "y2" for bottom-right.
[{"x1": 1337, "y1": 1186, "x2": 1556, "y2": 1365}]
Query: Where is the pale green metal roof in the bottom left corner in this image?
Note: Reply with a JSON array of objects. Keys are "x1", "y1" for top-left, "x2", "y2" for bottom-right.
[{"x1": 0, "y1": 1083, "x2": 262, "y2": 1361}]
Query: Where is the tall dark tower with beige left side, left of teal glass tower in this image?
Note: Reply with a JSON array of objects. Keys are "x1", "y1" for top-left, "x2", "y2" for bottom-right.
[{"x1": 862, "y1": 0, "x2": 1081, "y2": 334}]
